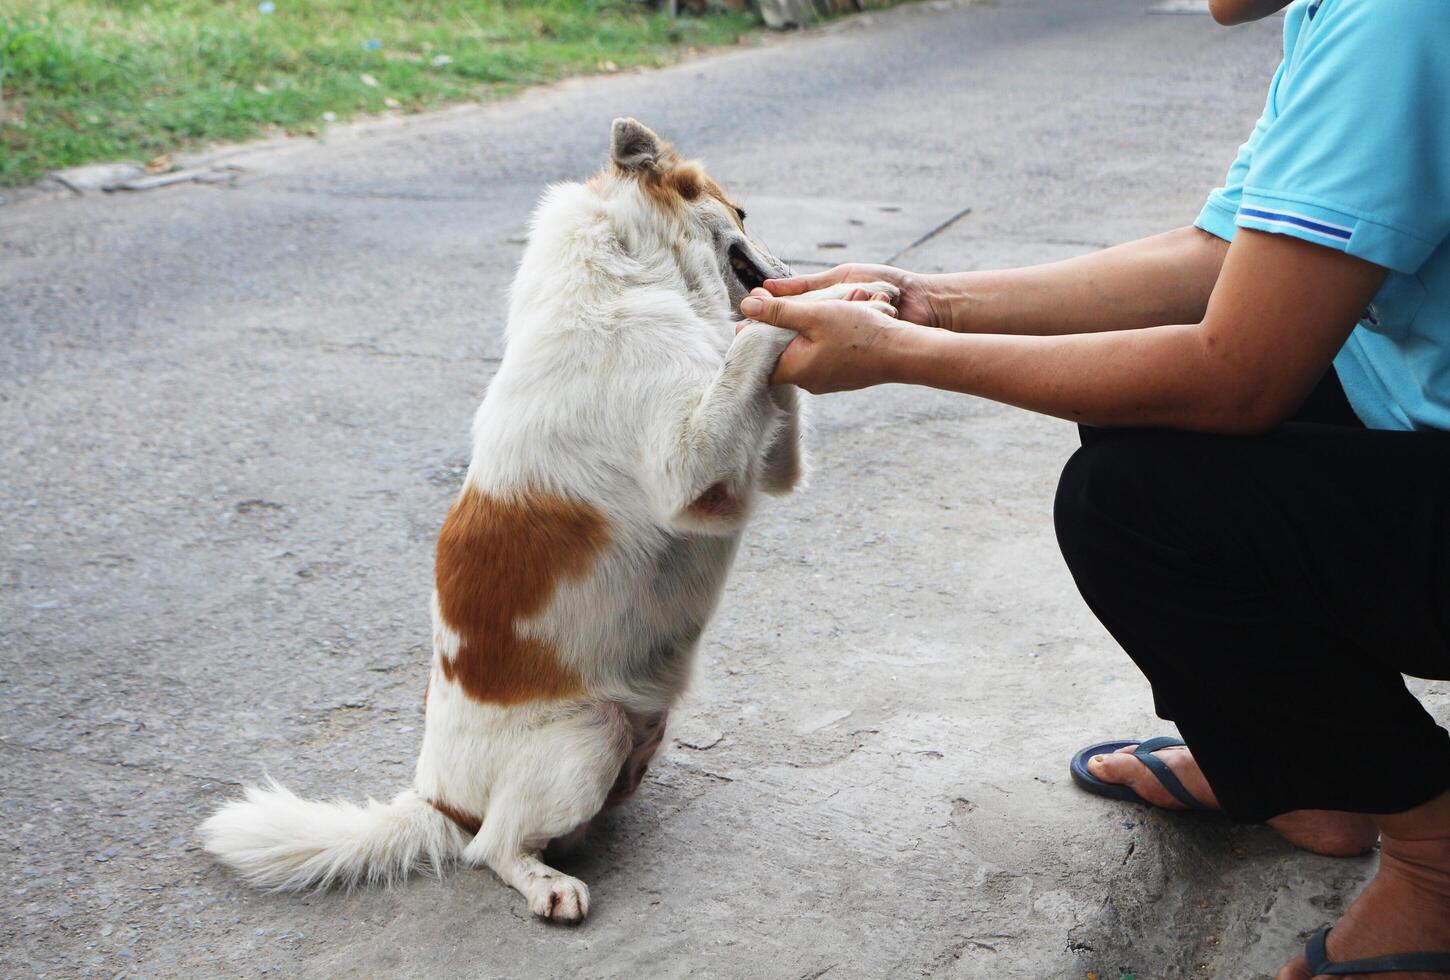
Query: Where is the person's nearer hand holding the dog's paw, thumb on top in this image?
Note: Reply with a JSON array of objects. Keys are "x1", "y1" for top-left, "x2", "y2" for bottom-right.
[{"x1": 740, "y1": 288, "x2": 918, "y2": 394}]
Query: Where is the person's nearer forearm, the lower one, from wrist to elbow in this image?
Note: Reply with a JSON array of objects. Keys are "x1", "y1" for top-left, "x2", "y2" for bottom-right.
[{"x1": 883, "y1": 325, "x2": 1285, "y2": 432}]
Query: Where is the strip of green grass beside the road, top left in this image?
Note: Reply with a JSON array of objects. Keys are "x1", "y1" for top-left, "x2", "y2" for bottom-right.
[{"x1": 0, "y1": 0, "x2": 755, "y2": 187}]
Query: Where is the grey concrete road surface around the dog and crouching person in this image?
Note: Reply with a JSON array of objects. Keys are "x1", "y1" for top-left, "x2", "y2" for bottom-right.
[{"x1": 0, "y1": 0, "x2": 1450, "y2": 980}]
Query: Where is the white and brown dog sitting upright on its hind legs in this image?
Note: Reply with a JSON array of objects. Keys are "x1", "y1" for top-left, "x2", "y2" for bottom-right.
[{"x1": 202, "y1": 119, "x2": 890, "y2": 922}]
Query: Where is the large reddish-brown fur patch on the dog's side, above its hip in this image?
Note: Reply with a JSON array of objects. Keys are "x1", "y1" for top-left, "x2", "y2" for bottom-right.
[{"x1": 435, "y1": 487, "x2": 609, "y2": 705}]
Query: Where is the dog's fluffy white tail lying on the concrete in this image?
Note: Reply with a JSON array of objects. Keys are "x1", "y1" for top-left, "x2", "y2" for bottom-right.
[{"x1": 202, "y1": 780, "x2": 468, "y2": 892}]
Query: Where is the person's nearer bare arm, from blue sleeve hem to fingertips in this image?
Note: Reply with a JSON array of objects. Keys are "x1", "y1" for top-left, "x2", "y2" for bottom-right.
[{"x1": 741, "y1": 229, "x2": 1386, "y2": 432}]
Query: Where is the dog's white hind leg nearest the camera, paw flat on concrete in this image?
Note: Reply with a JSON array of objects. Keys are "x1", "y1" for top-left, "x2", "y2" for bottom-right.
[{"x1": 463, "y1": 703, "x2": 631, "y2": 923}]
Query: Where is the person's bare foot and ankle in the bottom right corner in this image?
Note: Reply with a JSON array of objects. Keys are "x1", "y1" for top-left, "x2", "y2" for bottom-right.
[{"x1": 1275, "y1": 835, "x2": 1450, "y2": 980}]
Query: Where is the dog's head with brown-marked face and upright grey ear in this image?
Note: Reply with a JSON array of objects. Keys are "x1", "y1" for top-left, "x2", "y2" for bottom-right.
[{"x1": 609, "y1": 119, "x2": 790, "y2": 317}]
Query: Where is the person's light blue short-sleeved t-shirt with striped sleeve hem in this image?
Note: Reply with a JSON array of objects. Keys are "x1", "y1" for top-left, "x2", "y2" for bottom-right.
[{"x1": 1195, "y1": 0, "x2": 1450, "y2": 431}]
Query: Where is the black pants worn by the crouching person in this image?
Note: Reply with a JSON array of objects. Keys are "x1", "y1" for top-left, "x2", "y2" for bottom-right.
[{"x1": 1056, "y1": 371, "x2": 1450, "y2": 821}]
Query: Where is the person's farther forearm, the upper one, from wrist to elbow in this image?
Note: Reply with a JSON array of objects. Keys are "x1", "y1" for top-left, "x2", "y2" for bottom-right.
[{"x1": 929, "y1": 228, "x2": 1228, "y2": 335}]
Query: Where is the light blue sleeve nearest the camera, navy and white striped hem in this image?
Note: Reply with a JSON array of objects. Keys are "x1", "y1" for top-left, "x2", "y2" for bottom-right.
[{"x1": 1235, "y1": 0, "x2": 1450, "y2": 273}]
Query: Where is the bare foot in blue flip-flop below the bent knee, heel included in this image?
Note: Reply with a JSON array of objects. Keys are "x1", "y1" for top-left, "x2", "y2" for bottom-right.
[{"x1": 1088, "y1": 745, "x2": 1379, "y2": 857}]
